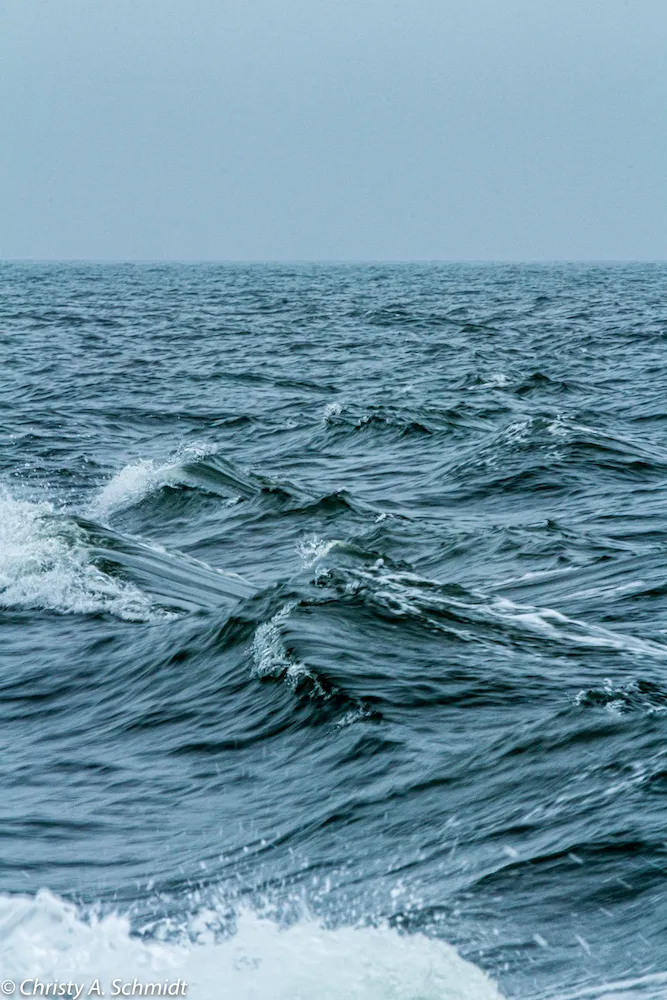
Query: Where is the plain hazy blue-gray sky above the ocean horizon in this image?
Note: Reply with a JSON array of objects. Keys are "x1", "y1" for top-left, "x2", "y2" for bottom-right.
[{"x1": 0, "y1": 0, "x2": 667, "y2": 260}]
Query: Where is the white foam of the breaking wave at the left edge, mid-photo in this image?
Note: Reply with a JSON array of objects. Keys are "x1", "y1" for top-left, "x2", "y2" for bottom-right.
[{"x1": 0, "y1": 489, "x2": 163, "y2": 621}]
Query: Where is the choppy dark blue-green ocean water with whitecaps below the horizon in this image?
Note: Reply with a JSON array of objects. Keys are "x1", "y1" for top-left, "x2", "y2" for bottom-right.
[{"x1": 0, "y1": 263, "x2": 667, "y2": 1000}]
